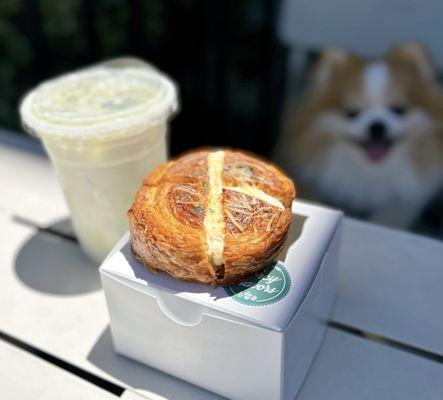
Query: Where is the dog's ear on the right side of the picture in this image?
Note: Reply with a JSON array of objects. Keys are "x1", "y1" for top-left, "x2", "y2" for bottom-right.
[{"x1": 388, "y1": 42, "x2": 435, "y2": 81}]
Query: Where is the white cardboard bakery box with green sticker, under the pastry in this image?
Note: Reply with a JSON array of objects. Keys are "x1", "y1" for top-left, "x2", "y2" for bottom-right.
[{"x1": 100, "y1": 201, "x2": 342, "y2": 400}]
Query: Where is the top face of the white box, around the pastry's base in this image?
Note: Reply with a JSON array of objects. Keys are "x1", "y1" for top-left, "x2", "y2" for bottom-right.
[{"x1": 100, "y1": 201, "x2": 342, "y2": 331}]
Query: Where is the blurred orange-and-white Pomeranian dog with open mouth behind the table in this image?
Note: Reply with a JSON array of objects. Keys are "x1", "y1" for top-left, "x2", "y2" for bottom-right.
[{"x1": 276, "y1": 43, "x2": 443, "y2": 228}]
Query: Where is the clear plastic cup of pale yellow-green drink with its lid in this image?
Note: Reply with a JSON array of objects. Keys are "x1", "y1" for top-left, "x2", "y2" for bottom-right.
[{"x1": 20, "y1": 58, "x2": 178, "y2": 263}]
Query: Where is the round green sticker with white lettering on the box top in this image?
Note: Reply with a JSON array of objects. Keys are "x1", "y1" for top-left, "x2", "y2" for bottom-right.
[{"x1": 224, "y1": 261, "x2": 291, "y2": 307}]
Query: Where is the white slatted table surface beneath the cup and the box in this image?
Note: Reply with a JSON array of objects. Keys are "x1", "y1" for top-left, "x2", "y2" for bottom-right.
[{"x1": 0, "y1": 132, "x2": 443, "y2": 400}]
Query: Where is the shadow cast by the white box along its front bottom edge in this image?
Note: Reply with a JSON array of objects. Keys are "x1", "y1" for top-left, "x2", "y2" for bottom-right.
[{"x1": 88, "y1": 326, "x2": 223, "y2": 400}]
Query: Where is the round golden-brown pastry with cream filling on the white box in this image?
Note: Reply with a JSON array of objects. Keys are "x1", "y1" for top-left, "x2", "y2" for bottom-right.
[{"x1": 128, "y1": 150, "x2": 295, "y2": 285}]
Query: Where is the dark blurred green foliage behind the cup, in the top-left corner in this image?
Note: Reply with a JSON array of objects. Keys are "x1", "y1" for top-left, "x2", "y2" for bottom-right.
[{"x1": 0, "y1": 0, "x2": 168, "y2": 129}]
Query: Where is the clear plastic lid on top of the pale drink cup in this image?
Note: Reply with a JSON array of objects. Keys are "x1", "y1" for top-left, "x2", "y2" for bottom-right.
[{"x1": 20, "y1": 57, "x2": 178, "y2": 140}]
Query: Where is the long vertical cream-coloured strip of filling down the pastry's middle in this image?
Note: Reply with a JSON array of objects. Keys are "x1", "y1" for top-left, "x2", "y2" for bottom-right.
[{"x1": 203, "y1": 151, "x2": 225, "y2": 266}]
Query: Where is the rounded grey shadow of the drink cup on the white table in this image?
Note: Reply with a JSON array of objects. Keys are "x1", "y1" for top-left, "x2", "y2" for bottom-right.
[{"x1": 15, "y1": 218, "x2": 101, "y2": 296}]
